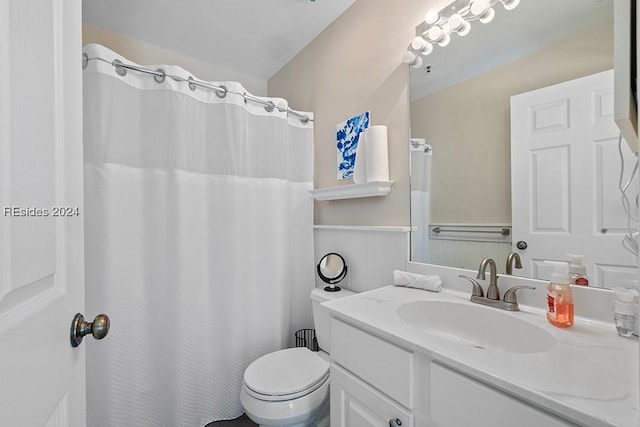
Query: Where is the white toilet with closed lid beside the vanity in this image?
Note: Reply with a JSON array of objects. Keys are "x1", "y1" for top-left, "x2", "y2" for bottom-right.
[{"x1": 240, "y1": 288, "x2": 353, "y2": 427}]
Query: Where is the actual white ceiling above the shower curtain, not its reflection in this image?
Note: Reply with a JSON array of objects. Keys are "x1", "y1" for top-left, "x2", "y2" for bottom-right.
[{"x1": 82, "y1": 0, "x2": 355, "y2": 80}]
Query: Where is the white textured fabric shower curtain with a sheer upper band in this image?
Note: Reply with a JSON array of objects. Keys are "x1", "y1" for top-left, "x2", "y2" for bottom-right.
[{"x1": 84, "y1": 45, "x2": 314, "y2": 427}]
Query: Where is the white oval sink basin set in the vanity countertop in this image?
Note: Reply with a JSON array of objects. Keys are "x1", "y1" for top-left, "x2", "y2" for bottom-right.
[{"x1": 397, "y1": 300, "x2": 556, "y2": 353}]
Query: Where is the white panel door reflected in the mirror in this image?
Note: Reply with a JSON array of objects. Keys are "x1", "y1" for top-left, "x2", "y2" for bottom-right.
[{"x1": 511, "y1": 71, "x2": 637, "y2": 287}]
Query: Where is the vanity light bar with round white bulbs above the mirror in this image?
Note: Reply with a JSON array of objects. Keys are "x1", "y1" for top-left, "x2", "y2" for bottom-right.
[{"x1": 402, "y1": 0, "x2": 520, "y2": 68}]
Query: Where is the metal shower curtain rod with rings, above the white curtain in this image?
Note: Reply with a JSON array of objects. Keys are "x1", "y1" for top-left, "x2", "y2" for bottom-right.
[{"x1": 82, "y1": 53, "x2": 313, "y2": 125}]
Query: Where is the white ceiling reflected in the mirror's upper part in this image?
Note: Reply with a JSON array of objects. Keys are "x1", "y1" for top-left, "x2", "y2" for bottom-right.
[{"x1": 411, "y1": 0, "x2": 614, "y2": 100}]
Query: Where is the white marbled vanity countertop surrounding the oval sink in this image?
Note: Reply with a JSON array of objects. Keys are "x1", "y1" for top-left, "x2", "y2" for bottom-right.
[{"x1": 324, "y1": 286, "x2": 640, "y2": 427}]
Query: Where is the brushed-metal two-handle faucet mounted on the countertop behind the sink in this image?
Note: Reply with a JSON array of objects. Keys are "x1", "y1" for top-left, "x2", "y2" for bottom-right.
[{"x1": 458, "y1": 254, "x2": 535, "y2": 311}]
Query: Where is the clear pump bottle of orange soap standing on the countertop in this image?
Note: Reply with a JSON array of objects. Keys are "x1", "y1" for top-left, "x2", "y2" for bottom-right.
[{"x1": 547, "y1": 261, "x2": 573, "y2": 328}]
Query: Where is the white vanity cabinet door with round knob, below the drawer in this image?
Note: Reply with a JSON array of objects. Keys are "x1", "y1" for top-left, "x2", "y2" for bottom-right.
[{"x1": 330, "y1": 363, "x2": 414, "y2": 427}]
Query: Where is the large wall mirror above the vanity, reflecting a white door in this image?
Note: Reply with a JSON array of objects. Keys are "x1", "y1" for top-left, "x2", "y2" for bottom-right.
[{"x1": 409, "y1": 0, "x2": 638, "y2": 288}]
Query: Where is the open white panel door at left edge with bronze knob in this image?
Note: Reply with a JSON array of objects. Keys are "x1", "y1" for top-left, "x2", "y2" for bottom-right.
[{"x1": 0, "y1": 0, "x2": 86, "y2": 427}]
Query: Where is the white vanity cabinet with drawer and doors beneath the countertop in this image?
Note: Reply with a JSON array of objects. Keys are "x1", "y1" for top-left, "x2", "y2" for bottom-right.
[{"x1": 330, "y1": 317, "x2": 577, "y2": 427}]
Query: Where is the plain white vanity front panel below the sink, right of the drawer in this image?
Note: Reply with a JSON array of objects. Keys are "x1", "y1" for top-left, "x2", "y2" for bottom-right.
[{"x1": 430, "y1": 363, "x2": 576, "y2": 427}]
